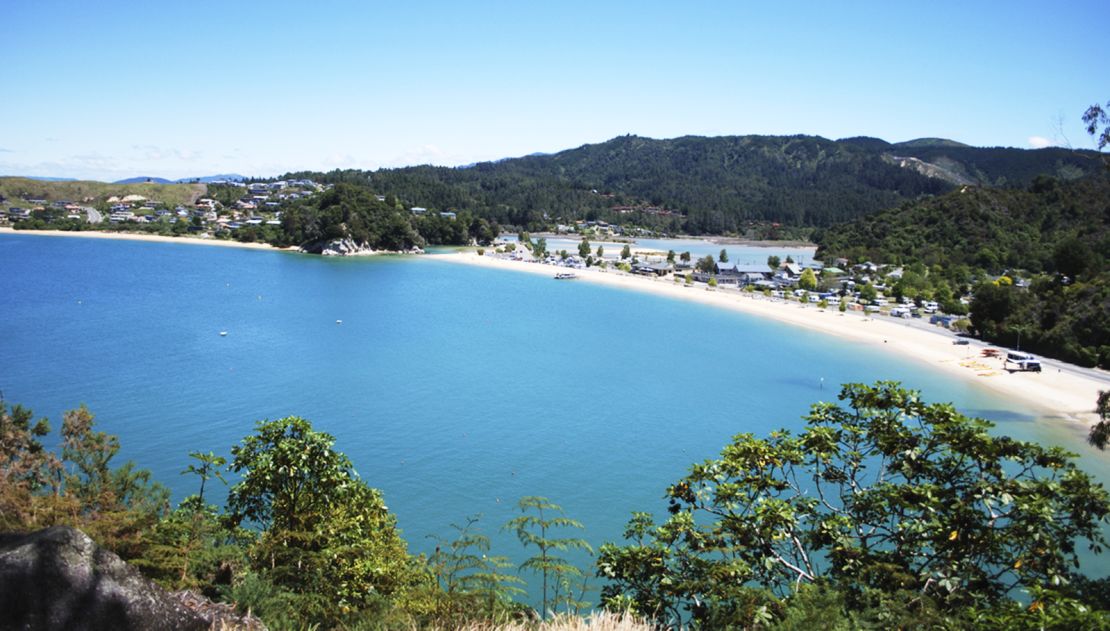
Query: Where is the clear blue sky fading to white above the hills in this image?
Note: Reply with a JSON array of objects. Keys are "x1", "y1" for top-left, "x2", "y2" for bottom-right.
[{"x1": 0, "y1": 0, "x2": 1110, "y2": 181}]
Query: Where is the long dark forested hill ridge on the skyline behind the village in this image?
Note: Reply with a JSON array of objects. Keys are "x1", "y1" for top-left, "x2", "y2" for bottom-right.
[{"x1": 286, "y1": 136, "x2": 1099, "y2": 233}]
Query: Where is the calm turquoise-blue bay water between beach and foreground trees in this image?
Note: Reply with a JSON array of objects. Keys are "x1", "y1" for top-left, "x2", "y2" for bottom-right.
[{"x1": 0, "y1": 234, "x2": 1110, "y2": 591}]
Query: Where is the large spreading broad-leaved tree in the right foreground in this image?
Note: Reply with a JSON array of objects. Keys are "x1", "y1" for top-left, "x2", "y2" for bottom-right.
[{"x1": 597, "y1": 382, "x2": 1110, "y2": 624}]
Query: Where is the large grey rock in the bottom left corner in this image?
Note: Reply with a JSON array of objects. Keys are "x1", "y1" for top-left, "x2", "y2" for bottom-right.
[{"x1": 0, "y1": 525, "x2": 261, "y2": 630}]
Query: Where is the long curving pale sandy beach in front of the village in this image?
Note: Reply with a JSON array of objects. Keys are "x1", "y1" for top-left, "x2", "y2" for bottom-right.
[{"x1": 430, "y1": 252, "x2": 1110, "y2": 429}]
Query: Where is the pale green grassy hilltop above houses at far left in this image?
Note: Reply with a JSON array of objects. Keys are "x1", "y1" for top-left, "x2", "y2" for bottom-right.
[{"x1": 0, "y1": 178, "x2": 208, "y2": 208}]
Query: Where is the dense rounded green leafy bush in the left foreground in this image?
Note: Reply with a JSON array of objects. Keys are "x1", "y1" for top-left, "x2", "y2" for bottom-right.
[{"x1": 228, "y1": 417, "x2": 418, "y2": 624}]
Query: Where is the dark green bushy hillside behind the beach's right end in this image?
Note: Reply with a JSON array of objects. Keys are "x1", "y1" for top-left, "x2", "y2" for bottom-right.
[{"x1": 815, "y1": 176, "x2": 1110, "y2": 368}]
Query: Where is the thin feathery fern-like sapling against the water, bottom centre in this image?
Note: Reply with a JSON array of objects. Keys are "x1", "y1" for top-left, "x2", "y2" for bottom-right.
[{"x1": 504, "y1": 495, "x2": 593, "y2": 618}]
